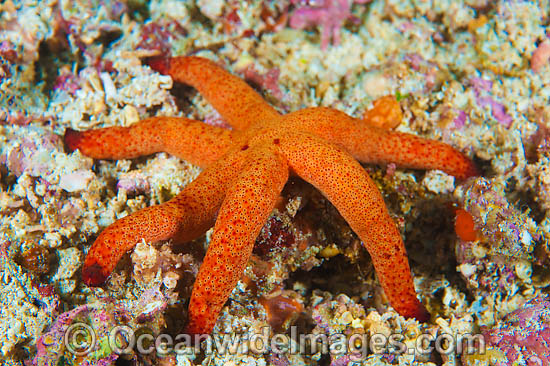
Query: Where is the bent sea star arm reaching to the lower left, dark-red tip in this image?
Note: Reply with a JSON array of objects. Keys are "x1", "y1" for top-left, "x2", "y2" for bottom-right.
[{"x1": 82, "y1": 149, "x2": 244, "y2": 286}]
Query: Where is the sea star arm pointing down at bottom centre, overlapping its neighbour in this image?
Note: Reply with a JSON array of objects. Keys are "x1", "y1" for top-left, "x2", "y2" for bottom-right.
[{"x1": 186, "y1": 148, "x2": 288, "y2": 334}]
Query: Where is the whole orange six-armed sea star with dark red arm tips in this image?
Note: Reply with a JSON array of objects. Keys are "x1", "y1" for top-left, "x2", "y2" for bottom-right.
[{"x1": 65, "y1": 57, "x2": 477, "y2": 334}]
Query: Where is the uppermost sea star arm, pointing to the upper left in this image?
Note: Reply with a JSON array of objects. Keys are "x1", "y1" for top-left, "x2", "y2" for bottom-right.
[{"x1": 148, "y1": 56, "x2": 280, "y2": 130}]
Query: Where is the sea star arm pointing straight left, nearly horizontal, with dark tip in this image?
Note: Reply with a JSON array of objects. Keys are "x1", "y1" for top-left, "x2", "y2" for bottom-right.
[{"x1": 64, "y1": 117, "x2": 233, "y2": 167}]
